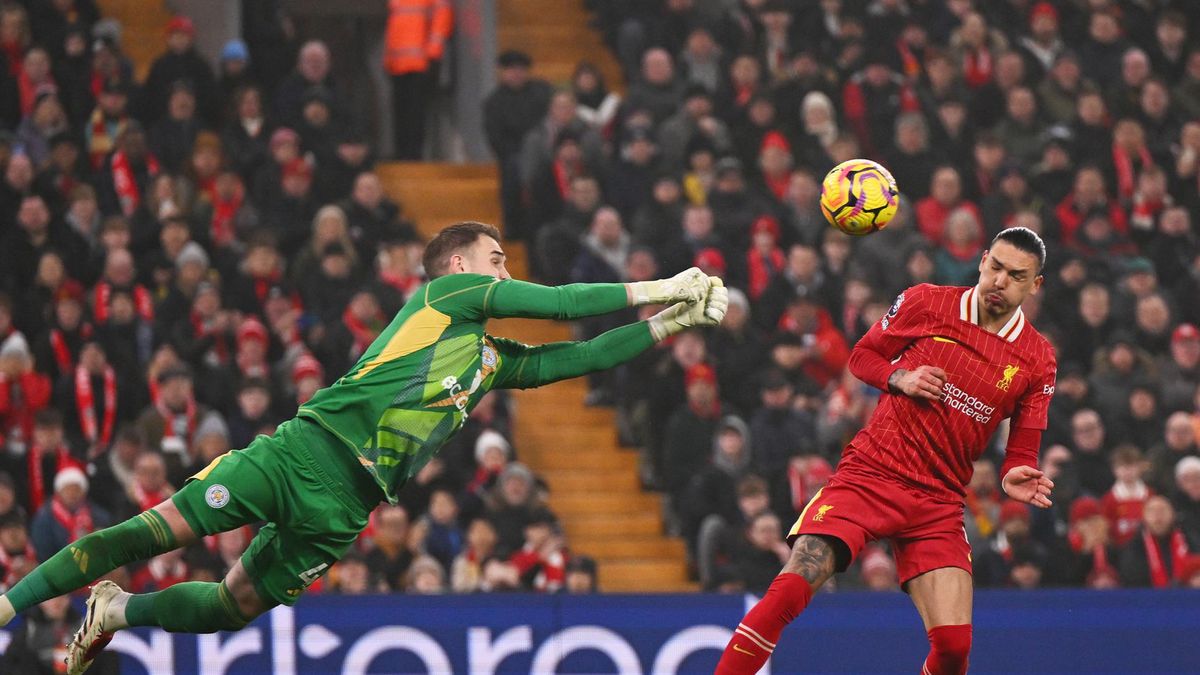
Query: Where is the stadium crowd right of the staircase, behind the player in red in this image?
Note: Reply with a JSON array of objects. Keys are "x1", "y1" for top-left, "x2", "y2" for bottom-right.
[{"x1": 485, "y1": 0, "x2": 1200, "y2": 591}]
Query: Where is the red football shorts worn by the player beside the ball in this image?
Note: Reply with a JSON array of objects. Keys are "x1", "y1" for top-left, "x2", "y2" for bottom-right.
[{"x1": 787, "y1": 461, "x2": 971, "y2": 585}]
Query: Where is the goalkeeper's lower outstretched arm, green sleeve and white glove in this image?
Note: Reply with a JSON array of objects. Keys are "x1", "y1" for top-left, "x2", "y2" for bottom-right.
[{"x1": 494, "y1": 277, "x2": 728, "y2": 389}]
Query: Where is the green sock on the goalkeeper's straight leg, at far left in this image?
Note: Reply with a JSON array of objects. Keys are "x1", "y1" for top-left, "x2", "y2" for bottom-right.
[{"x1": 6, "y1": 510, "x2": 176, "y2": 614}]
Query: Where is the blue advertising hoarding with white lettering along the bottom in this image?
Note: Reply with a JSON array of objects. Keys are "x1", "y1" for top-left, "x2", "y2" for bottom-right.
[{"x1": 0, "y1": 591, "x2": 1200, "y2": 675}]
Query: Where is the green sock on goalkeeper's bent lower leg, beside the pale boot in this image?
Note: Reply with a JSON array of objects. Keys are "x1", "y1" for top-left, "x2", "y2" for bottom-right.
[{"x1": 125, "y1": 581, "x2": 250, "y2": 633}]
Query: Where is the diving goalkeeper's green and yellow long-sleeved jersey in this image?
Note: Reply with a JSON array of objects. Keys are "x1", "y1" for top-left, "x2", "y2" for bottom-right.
[{"x1": 298, "y1": 274, "x2": 653, "y2": 503}]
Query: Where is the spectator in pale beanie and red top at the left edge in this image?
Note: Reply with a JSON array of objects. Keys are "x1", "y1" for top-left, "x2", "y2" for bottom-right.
[{"x1": 0, "y1": 333, "x2": 53, "y2": 456}]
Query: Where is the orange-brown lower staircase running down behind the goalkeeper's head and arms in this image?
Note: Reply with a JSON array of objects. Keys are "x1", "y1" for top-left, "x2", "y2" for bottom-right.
[{"x1": 379, "y1": 162, "x2": 695, "y2": 592}]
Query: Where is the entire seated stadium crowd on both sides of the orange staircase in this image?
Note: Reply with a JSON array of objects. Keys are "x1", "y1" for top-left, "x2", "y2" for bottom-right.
[{"x1": 0, "y1": 0, "x2": 1200, "y2": 653}]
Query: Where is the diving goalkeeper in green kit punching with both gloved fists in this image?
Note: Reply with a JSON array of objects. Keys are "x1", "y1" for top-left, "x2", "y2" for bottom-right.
[{"x1": 0, "y1": 222, "x2": 727, "y2": 674}]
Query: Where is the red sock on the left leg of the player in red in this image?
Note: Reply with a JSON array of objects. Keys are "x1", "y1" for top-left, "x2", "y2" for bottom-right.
[{"x1": 713, "y1": 572, "x2": 812, "y2": 675}]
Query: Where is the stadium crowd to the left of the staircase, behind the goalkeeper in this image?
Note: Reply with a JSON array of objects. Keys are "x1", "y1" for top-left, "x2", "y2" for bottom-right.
[{"x1": 0, "y1": 0, "x2": 596, "y2": 653}]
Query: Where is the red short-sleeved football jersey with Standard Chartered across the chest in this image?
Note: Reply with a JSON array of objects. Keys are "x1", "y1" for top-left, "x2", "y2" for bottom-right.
[{"x1": 839, "y1": 283, "x2": 1057, "y2": 501}]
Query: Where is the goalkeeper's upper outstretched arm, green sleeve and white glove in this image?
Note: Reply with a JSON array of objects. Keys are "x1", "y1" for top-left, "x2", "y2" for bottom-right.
[{"x1": 484, "y1": 268, "x2": 712, "y2": 321}]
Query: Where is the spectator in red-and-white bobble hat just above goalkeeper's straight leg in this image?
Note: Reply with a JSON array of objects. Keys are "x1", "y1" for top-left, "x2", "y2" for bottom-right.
[{"x1": 30, "y1": 466, "x2": 112, "y2": 562}]
